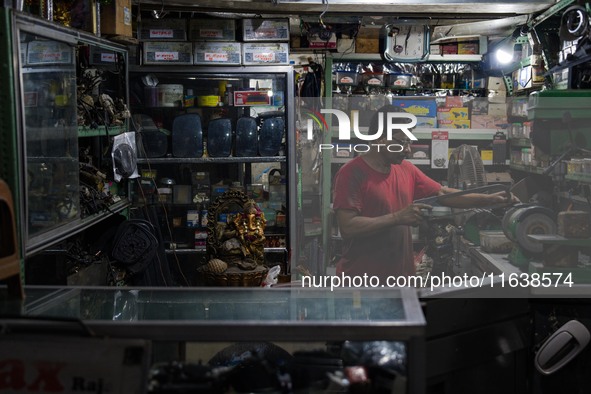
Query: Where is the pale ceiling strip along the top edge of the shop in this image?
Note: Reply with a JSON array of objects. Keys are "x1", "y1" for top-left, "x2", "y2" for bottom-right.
[{"x1": 134, "y1": 0, "x2": 564, "y2": 38}]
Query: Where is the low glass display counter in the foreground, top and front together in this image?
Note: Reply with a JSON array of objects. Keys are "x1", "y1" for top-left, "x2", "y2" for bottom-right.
[{"x1": 0, "y1": 287, "x2": 425, "y2": 394}]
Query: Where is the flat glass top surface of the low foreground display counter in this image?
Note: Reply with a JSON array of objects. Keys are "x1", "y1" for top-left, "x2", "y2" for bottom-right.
[{"x1": 0, "y1": 286, "x2": 425, "y2": 341}]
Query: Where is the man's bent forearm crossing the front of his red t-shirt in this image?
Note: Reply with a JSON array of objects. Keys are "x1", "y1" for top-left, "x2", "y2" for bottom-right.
[{"x1": 337, "y1": 204, "x2": 432, "y2": 238}]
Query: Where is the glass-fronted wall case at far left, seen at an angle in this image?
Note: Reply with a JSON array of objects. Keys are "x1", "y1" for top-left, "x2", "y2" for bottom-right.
[{"x1": 2, "y1": 10, "x2": 128, "y2": 256}]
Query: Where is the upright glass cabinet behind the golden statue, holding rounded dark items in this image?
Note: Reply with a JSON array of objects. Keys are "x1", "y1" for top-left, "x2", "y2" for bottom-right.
[{"x1": 129, "y1": 65, "x2": 296, "y2": 284}]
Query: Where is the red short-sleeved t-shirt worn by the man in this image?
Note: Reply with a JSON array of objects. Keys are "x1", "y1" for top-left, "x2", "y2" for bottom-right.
[{"x1": 333, "y1": 157, "x2": 441, "y2": 284}]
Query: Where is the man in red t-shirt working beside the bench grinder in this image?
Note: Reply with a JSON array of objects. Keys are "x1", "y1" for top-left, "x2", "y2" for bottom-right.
[{"x1": 333, "y1": 105, "x2": 520, "y2": 283}]
